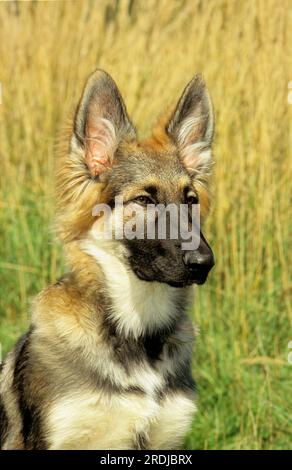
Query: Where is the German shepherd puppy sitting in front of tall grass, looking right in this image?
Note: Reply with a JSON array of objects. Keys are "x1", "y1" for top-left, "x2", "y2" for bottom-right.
[{"x1": 0, "y1": 70, "x2": 214, "y2": 449}]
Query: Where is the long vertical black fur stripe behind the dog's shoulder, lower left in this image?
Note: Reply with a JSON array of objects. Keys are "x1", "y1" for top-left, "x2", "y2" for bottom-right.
[{"x1": 13, "y1": 329, "x2": 46, "y2": 450}]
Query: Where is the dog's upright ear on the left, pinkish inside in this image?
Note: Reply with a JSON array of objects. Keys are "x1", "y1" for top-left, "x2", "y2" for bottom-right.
[{"x1": 74, "y1": 70, "x2": 135, "y2": 176}]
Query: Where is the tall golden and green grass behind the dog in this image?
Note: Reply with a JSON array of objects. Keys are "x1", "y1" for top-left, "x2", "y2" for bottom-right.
[{"x1": 0, "y1": 0, "x2": 292, "y2": 449}]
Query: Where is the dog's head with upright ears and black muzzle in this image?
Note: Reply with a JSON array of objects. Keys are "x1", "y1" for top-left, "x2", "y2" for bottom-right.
[{"x1": 58, "y1": 71, "x2": 214, "y2": 287}]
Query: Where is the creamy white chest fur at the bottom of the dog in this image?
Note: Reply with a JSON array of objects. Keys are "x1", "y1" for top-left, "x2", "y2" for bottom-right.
[{"x1": 47, "y1": 393, "x2": 195, "y2": 450}]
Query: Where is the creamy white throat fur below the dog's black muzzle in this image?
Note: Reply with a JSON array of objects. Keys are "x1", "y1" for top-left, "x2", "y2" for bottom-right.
[{"x1": 76, "y1": 234, "x2": 191, "y2": 338}]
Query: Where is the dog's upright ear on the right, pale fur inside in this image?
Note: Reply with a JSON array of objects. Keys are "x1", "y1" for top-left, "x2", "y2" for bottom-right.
[{"x1": 166, "y1": 75, "x2": 214, "y2": 175}]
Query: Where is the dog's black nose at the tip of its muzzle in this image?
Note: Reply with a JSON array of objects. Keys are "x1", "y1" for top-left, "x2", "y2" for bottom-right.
[{"x1": 183, "y1": 234, "x2": 215, "y2": 284}]
